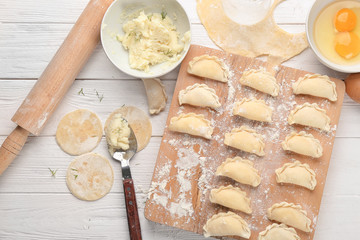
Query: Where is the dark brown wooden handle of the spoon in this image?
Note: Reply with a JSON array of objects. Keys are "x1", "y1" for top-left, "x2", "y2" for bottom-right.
[{"x1": 123, "y1": 178, "x2": 141, "y2": 240}]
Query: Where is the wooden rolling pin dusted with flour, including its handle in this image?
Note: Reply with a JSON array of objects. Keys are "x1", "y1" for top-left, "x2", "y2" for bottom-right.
[{"x1": 0, "y1": 0, "x2": 113, "y2": 175}]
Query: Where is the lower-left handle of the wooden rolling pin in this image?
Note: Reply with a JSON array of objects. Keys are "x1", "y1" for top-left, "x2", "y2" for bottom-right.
[{"x1": 0, "y1": 126, "x2": 29, "y2": 175}]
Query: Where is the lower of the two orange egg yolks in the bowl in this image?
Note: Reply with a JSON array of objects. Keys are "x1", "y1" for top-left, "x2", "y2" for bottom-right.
[{"x1": 335, "y1": 32, "x2": 360, "y2": 59}]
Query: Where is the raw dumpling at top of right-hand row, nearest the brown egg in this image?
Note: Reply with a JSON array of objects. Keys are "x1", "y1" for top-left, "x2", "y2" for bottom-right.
[{"x1": 292, "y1": 74, "x2": 337, "y2": 101}]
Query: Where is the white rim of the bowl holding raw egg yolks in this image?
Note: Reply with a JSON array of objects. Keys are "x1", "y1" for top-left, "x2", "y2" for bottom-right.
[{"x1": 305, "y1": 0, "x2": 360, "y2": 73}]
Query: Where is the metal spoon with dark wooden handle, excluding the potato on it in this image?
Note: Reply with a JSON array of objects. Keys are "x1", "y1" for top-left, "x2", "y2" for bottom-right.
[{"x1": 108, "y1": 119, "x2": 142, "y2": 240}]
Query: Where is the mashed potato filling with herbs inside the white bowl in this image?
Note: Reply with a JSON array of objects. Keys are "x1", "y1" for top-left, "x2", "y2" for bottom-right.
[{"x1": 116, "y1": 11, "x2": 190, "y2": 72}]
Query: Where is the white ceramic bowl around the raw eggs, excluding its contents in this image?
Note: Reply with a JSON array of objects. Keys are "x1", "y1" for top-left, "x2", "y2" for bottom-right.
[{"x1": 306, "y1": 0, "x2": 360, "y2": 73}]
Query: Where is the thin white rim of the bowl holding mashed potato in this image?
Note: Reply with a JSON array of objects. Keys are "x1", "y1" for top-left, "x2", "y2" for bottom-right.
[{"x1": 100, "y1": 0, "x2": 192, "y2": 79}]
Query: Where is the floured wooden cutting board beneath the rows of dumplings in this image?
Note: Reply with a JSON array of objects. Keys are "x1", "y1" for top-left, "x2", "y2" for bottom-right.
[{"x1": 145, "y1": 46, "x2": 345, "y2": 240}]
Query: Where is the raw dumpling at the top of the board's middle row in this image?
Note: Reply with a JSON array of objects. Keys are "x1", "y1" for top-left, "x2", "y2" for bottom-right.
[{"x1": 239, "y1": 69, "x2": 280, "y2": 97}]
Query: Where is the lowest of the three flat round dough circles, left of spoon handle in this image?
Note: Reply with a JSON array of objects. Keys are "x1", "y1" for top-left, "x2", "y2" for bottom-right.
[{"x1": 66, "y1": 153, "x2": 114, "y2": 201}]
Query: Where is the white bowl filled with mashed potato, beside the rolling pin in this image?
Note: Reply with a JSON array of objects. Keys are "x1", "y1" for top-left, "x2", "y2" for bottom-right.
[{"x1": 101, "y1": 0, "x2": 191, "y2": 78}]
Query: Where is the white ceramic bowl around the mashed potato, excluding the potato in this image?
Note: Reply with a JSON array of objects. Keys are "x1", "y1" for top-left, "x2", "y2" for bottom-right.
[{"x1": 101, "y1": 0, "x2": 191, "y2": 78}]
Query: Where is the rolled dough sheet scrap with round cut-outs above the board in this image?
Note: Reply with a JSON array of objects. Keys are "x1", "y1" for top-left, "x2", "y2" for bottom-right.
[{"x1": 197, "y1": 0, "x2": 308, "y2": 65}]
